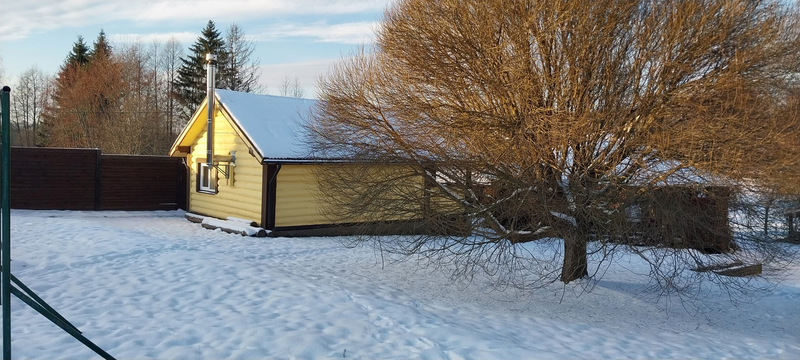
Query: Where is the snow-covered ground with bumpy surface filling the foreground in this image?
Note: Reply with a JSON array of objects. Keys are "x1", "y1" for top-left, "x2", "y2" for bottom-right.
[{"x1": 0, "y1": 210, "x2": 800, "y2": 359}]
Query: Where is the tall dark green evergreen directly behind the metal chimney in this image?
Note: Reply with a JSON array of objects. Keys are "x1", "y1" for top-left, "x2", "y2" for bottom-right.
[{"x1": 174, "y1": 20, "x2": 228, "y2": 116}]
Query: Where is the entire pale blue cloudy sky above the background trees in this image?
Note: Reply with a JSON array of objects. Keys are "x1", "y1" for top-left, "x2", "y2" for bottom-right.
[{"x1": 0, "y1": 0, "x2": 391, "y2": 96}]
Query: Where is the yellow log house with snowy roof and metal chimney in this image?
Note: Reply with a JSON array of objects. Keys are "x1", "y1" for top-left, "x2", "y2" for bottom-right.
[{"x1": 169, "y1": 89, "x2": 346, "y2": 235}]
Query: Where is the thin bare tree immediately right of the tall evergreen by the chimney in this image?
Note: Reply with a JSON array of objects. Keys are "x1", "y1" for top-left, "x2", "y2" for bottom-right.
[{"x1": 224, "y1": 23, "x2": 261, "y2": 93}]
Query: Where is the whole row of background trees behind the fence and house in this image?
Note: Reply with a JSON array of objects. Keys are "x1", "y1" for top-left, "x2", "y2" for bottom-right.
[{"x1": 3, "y1": 21, "x2": 272, "y2": 154}]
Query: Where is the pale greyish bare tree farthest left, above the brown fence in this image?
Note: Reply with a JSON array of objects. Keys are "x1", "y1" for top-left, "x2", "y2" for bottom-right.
[{"x1": 11, "y1": 66, "x2": 53, "y2": 146}]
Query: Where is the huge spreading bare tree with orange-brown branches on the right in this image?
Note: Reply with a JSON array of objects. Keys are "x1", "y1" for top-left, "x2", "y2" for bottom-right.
[{"x1": 309, "y1": 0, "x2": 800, "y2": 298}]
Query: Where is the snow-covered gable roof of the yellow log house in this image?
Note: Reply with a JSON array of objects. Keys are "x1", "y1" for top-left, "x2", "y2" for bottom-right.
[{"x1": 170, "y1": 89, "x2": 317, "y2": 162}]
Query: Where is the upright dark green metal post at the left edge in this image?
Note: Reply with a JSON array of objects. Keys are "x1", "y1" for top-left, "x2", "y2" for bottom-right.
[{"x1": 0, "y1": 86, "x2": 11, "y2": 360}]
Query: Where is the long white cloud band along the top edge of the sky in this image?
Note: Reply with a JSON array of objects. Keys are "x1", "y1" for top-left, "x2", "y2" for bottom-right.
[{"x1": 0, "y1": 0, "x2": 391, "y2": 40}]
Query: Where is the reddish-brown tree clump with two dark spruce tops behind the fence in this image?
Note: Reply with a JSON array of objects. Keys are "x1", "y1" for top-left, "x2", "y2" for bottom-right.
[{"x1": 42, "y1": 32, "x2": 180, "y2": 155}]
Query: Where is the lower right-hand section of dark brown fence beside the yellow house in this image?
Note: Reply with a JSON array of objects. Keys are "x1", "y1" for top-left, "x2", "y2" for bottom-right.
[{"x1": 100, "y1": 155, "x2": 186, "y2": 210}]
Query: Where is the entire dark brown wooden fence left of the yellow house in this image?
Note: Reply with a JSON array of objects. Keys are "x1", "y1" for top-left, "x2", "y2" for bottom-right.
[{"x1": 3, "y1": 147, "x2": 187, "y2": 210}]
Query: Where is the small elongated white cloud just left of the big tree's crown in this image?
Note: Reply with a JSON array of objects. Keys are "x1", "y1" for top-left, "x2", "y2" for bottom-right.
[{"x1": 254, "y1": 21, "x2": 379, "y2": 44}]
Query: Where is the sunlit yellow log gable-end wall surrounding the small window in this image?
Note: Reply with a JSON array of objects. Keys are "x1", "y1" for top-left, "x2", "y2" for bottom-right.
[{"x1": 187, "y1": 112, "x2": 262, "y2": 224}]
